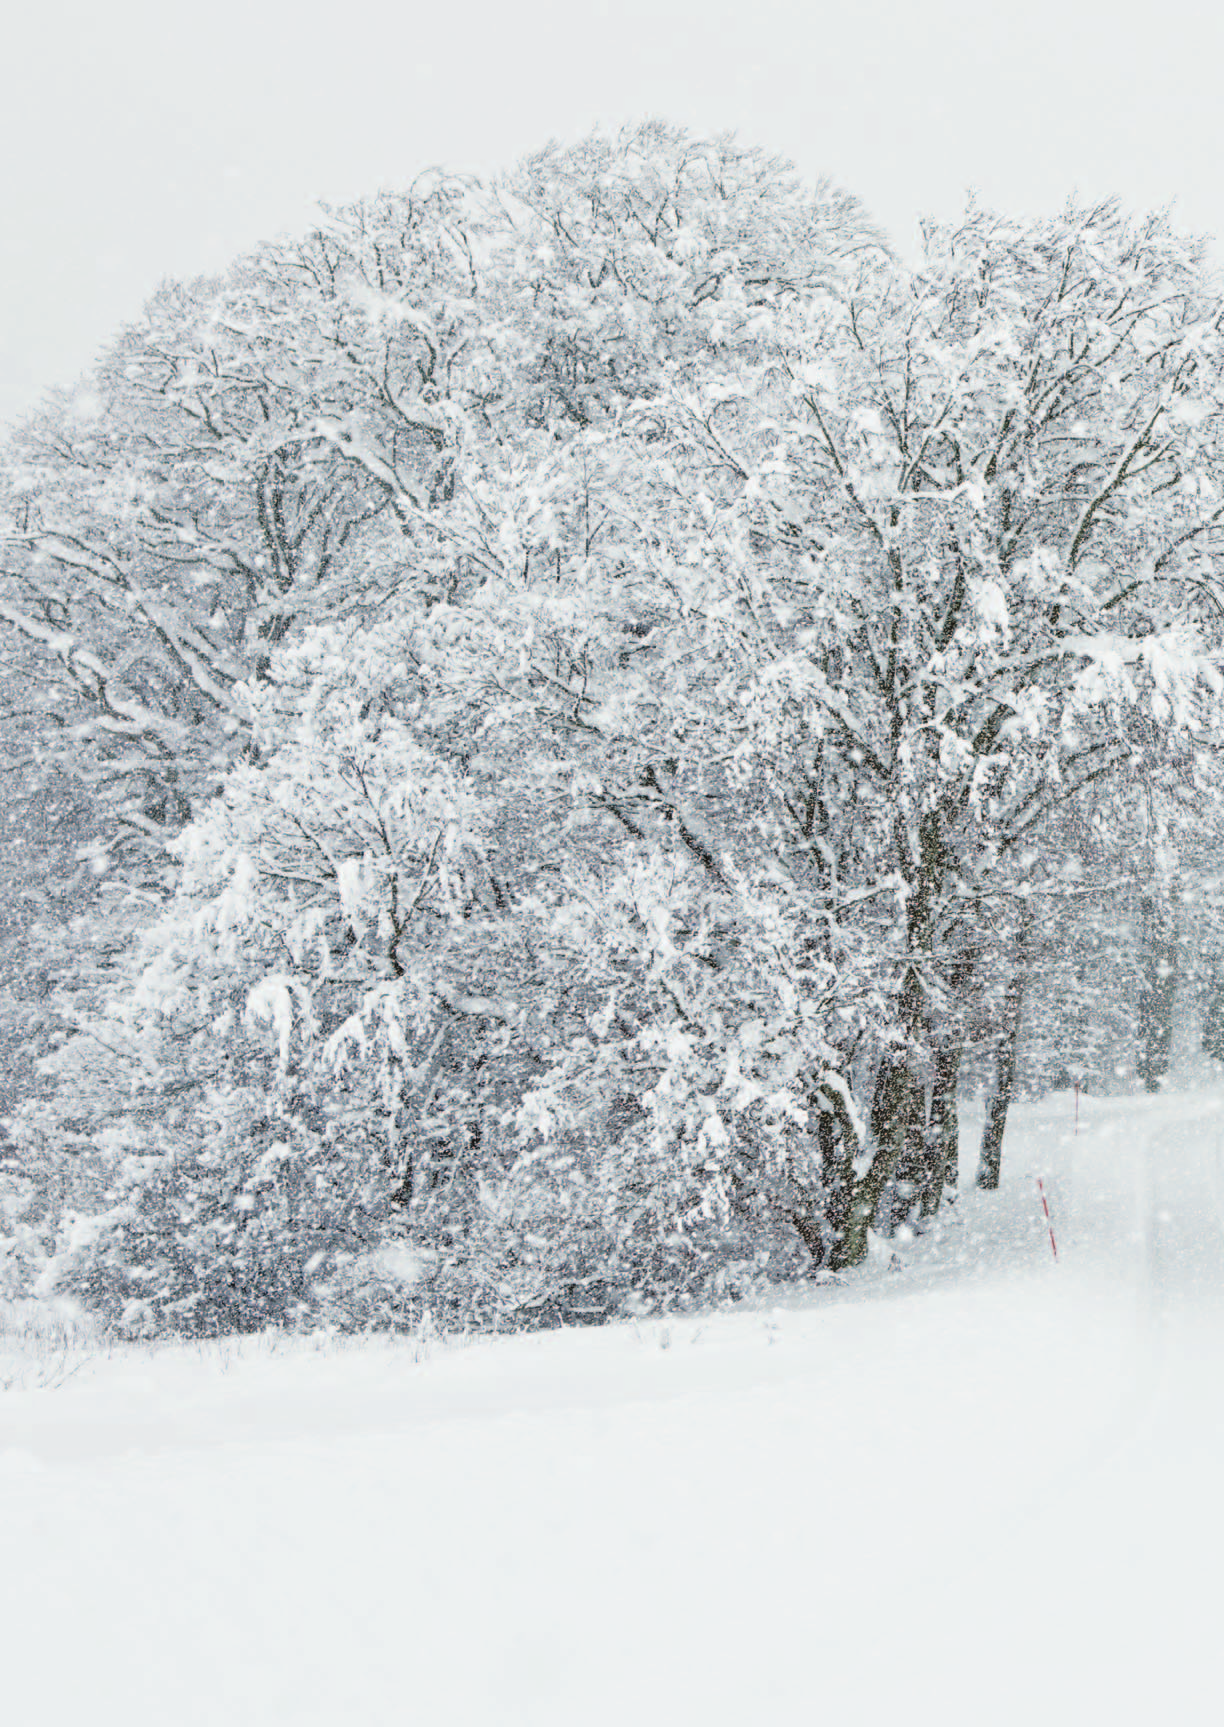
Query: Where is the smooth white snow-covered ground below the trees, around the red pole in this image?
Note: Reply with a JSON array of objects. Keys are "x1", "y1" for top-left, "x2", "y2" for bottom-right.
[{"x1": 0, "y1": 1091, "x2": 1224, "y2": 1727}]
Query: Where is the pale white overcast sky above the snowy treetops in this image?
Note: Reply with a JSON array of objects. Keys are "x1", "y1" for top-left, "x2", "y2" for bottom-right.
[{"x1": 0, "y1": 0, "x2": 1224, "y2": 420}]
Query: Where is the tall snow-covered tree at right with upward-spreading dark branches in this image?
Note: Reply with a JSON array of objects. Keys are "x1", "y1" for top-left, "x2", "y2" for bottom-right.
[{"x1": 735, "y1": 196, "x2": 1224, "y2": 1259}]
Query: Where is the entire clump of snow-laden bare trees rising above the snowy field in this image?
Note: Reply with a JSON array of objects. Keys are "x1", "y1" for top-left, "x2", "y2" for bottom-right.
[{"x1": 0, "y1": 126, "x2": 1224, "y2": 1332}]
